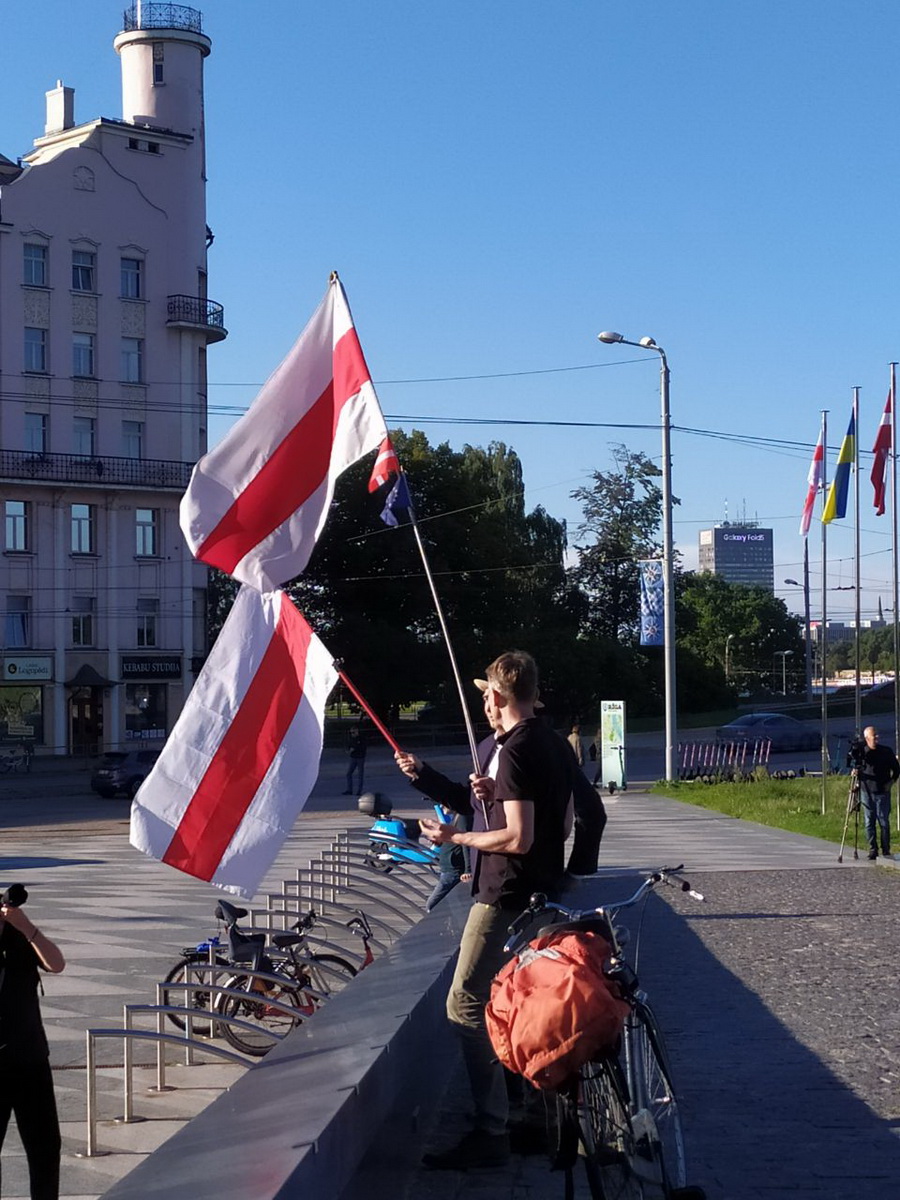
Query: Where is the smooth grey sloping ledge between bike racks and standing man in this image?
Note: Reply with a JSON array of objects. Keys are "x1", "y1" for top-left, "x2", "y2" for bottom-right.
[{"x1": 104, "y1": 888, "x2": 469, "y2": 1200}]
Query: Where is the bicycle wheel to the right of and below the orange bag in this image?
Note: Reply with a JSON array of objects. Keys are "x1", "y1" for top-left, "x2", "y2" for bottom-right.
[{"x1": 631, "y1": 1003, "x2": 685, "y2": 1194}]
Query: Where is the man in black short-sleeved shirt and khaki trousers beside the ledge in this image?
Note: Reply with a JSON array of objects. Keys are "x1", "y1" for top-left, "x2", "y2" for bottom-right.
[{"x1": 420, "y1": 650, "x2": 575, "y2": 1170}]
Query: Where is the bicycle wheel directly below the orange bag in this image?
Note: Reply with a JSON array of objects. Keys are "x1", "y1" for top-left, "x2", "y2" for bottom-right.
[{"x1": 578, "y1": 1058, "x2": 644, "y2": 1200}]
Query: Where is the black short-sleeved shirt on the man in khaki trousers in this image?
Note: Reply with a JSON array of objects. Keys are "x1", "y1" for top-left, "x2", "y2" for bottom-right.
[{"x1": 473, "y1": 716, "x2": 575, "y2": 910}]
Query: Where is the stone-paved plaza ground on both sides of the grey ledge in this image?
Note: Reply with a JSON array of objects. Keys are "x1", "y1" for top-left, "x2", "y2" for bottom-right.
[{"x1": 0, "y1": 755, "x2": 900, "y2": 1200}]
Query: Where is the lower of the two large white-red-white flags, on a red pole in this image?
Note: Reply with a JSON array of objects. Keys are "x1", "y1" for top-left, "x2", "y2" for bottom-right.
[{"x1": 131, "y1": 587, "x2": 337, "y2": 899}]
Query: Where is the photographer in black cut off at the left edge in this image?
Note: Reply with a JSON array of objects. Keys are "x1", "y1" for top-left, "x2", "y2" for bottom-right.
[{"x1": 0, "y1": 883, "x2": 66, "y2": 1200}]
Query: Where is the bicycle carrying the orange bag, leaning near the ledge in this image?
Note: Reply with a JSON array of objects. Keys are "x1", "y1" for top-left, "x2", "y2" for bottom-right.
[{"x1": 505, "y1": 866, "x2": 704, "y2": 1200}]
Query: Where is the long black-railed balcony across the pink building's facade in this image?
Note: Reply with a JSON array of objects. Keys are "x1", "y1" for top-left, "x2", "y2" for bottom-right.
[{"x1": 0, "y1": 450, "x2": 193, "y2": 492}]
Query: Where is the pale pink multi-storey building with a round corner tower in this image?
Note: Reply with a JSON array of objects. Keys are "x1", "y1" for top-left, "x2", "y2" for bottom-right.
[{"x1": 0, "y1": 2, "x2": 226, "y2": 755}]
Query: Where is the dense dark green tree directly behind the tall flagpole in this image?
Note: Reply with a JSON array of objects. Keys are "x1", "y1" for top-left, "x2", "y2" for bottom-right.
[{"x1": 290, "y1": 431, "x2": 581, "y2": 714}]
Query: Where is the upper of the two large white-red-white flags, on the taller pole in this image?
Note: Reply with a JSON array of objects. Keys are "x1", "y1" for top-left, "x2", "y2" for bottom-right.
[{"x1": 180, "y1": 276, "x2": 388, "y2": 592}]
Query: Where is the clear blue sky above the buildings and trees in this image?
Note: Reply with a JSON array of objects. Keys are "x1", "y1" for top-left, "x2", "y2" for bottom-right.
[{"x1": 0, "y1": 0, "x2": 900, "y2": 648}]
